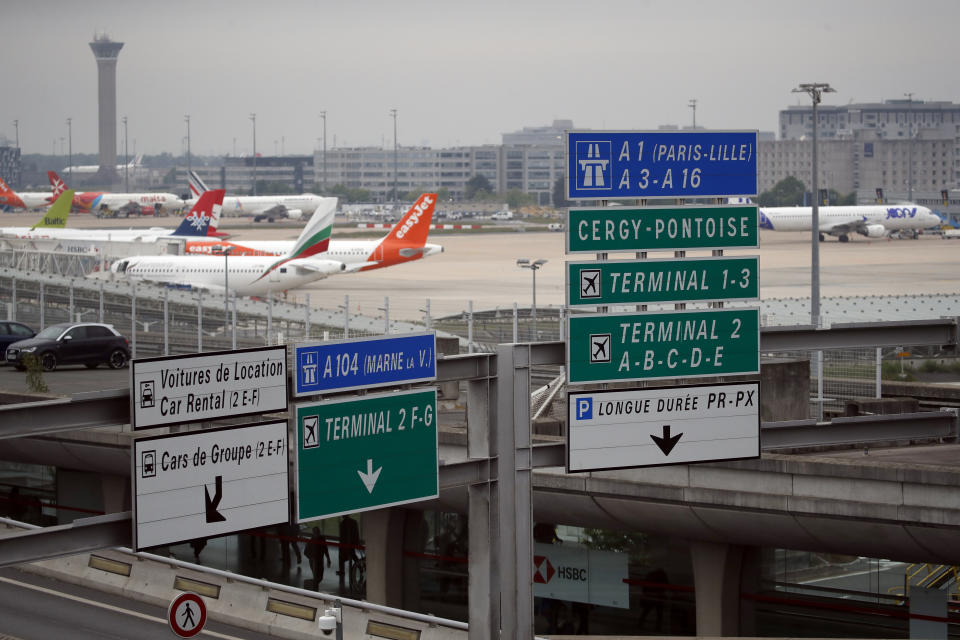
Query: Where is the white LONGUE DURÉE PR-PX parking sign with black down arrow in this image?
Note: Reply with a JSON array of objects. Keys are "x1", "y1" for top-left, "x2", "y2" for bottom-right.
[{"x1": 567, "y1": 382, "x2": 760, "y2": 472}]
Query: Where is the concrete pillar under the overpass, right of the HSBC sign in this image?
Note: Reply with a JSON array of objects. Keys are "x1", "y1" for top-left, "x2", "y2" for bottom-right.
[{"x1": 690, "y1": 542, "x2": 744, "y2": 637}]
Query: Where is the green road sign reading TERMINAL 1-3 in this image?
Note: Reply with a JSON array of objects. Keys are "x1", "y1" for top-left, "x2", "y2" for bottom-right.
[{"x1": 567, "y1": 256, "x2": 760, "y2": 307}]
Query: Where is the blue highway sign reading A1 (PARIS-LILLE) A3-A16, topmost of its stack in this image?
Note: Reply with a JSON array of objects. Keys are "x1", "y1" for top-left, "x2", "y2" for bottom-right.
[{"x1": 566, "y1": 131, "x2": 757, "y2": 200}]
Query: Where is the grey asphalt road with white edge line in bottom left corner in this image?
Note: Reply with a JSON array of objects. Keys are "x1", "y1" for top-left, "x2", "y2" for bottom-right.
[{"x1": 0, "y1": 569, "x2": 263, "y2": 640}]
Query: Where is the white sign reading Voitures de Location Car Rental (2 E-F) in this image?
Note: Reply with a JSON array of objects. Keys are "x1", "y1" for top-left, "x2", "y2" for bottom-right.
[{"x1": 130, "y1": 346, "x2": 287, "y2": 430}]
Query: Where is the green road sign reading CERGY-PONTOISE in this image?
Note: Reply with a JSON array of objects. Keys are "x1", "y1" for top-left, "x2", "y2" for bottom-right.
[{"x1": 567, "y1": 204, "x2": 757, "y2": 253}]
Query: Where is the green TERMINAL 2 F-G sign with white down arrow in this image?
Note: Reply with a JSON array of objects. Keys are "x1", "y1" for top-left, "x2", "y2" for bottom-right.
[{"x1": 295, "y1": 388, "x2": 438, "y2": 522}]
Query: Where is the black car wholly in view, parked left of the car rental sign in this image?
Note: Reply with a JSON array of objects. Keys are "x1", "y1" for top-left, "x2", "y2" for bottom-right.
[{"x1": 7, "y1": 322, "x2": 130, "y2": 371}]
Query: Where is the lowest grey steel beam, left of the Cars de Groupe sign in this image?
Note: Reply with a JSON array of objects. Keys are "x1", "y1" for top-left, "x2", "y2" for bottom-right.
[{"x1": 0, "y1": 511, "x2": 133, "y2": 567}]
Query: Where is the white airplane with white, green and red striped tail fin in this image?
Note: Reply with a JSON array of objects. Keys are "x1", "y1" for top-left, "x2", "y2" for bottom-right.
[{"x1": 110, "y1": 199, "x2": 345, "y2": 296}]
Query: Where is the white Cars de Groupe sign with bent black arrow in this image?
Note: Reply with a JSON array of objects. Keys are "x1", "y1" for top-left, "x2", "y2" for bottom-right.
[{"x1": 132, "y1": 421, "x2": 290, "y2": 551}]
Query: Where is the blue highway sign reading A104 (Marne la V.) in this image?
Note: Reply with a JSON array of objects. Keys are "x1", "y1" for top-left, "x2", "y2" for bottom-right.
[{"x1": 294, "y1": 332, "x2": 437, "y2": 397}]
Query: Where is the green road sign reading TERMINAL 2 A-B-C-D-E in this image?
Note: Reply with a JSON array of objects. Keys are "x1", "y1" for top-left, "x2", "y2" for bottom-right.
[{"x1": 567, "y1": 308, "x2": 760, "y2": 384}]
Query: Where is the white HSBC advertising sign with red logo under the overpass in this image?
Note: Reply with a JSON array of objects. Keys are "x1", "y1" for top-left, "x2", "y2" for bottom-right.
[{"x1": 533, "y1": 542, "x2": 630, "y2": 609}]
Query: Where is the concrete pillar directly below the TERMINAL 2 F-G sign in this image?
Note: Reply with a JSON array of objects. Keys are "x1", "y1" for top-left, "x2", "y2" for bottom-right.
[{"x1": 363, "y1": 508, "x2": 406, "y2": 608}]
